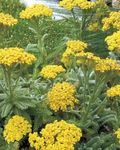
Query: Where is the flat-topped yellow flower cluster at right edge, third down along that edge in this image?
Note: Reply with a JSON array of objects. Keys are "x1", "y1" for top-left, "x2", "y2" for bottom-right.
[{"x1": 95, "y1": 58, "x2": 120, "y2": 72}]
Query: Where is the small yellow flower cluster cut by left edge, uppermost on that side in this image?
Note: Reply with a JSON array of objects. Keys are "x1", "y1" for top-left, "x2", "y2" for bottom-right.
[{"x1": 0, "y1": 12, "x2": 18, "y2": 26}]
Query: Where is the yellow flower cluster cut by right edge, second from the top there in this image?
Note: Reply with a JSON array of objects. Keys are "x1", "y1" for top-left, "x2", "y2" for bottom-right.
[{"x1": 105, "y1": 31, "x2": 120, "y2": 53}]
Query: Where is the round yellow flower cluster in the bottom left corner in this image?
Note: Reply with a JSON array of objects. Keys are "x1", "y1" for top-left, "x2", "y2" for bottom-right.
[{"x1": 3, "y1": 115, "x2": 31, "y2": 143}]
